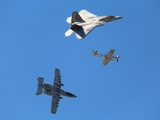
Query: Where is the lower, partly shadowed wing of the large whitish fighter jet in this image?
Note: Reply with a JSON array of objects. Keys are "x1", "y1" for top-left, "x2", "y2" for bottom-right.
[{"x1": 75, "y1": 24, "x2": 95, "y2": 39}]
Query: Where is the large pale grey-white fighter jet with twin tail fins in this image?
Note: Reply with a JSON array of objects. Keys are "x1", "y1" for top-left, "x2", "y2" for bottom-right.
[{"x1": 65, "y1": 10, "x2": 122, "y2": 39}]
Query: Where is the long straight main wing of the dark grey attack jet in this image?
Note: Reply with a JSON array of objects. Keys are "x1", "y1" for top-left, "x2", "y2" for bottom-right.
[{"x1": 51, "y1": 68, "x2": 62, "y2": 114}]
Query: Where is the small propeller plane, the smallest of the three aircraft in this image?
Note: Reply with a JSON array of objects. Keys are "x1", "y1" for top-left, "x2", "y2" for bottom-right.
[{"x1": 92, "y1": 49, "x2": 120, "y2": 65}]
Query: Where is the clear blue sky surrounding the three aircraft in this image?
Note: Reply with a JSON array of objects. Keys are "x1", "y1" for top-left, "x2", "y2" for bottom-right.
[{"x1": 0, "y1": 0, "x2": 160, "y2": 120}]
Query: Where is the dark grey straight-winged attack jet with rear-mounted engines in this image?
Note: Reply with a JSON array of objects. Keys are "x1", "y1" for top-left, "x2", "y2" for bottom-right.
[{"x1": 36, "y1": 68, "x2": 77, "y2": 114}]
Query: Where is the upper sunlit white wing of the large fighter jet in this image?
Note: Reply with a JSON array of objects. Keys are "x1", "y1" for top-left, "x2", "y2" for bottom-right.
[{"x1": 79, "y1": 10, "x2": 96, "y2": 20}]
